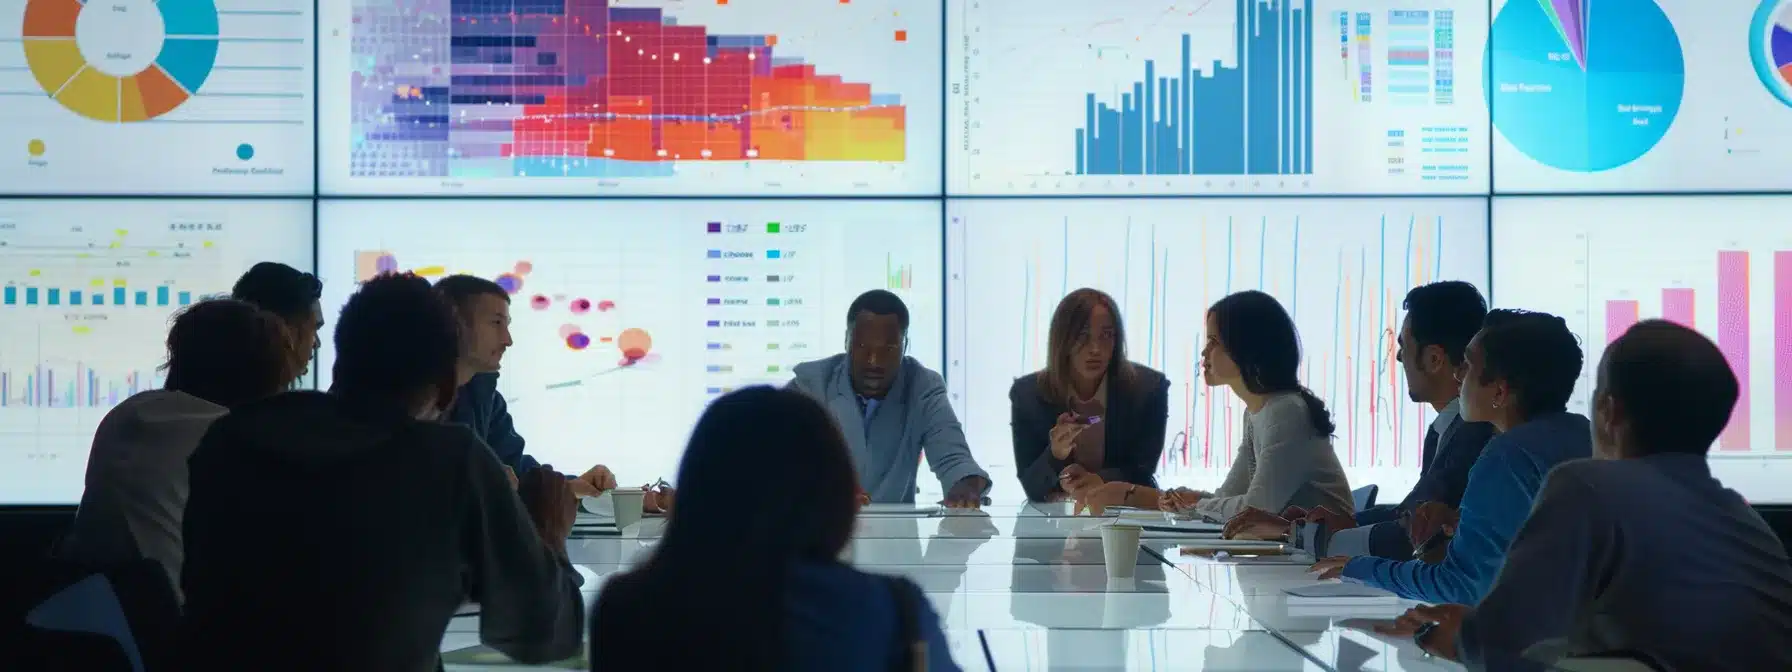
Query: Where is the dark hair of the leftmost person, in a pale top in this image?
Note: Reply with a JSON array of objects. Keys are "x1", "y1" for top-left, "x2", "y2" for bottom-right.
[{"x1": 161, "y1": 297, "x2": 299, "y2": 409}]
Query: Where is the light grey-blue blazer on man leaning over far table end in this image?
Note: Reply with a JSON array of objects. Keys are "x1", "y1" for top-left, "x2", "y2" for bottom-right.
[{"x1": 790, "y1": 353, "x2": 989, "y2": 504}]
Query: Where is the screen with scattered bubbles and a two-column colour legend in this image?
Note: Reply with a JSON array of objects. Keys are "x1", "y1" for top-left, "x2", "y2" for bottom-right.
[{"x1": 317, "y1": 201, "x2": 944, "y2": 486}]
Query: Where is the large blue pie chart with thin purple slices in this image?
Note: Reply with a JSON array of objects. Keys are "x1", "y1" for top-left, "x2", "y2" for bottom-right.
[{"x1": 1487, "y1": 0, "x2": 1686, "y2": 172}]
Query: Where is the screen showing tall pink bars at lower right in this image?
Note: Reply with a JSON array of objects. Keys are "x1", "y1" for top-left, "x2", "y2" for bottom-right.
[{"x1": 1493, "y1": 195, "x2": 1792, "y2": 504}]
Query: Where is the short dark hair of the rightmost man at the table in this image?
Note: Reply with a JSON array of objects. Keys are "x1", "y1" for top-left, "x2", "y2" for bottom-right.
[{"x1": 1602, "y1": 319, "x2": 1742, "y2": 455}]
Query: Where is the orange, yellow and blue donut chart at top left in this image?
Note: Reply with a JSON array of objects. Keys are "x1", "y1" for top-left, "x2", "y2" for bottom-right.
[{"x1": 22, "y1": 0, "x2": 219, "y2": 124}]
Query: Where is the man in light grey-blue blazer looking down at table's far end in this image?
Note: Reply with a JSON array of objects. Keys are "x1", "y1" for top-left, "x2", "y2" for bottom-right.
[{"x1": 790, "y1": 290, "x2": 989, "y2": 507}]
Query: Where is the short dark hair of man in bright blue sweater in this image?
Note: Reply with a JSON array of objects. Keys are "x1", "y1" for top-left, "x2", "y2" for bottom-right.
[{"x1": 1480, "y1": 308, "x2": 1586, "y2": 418}]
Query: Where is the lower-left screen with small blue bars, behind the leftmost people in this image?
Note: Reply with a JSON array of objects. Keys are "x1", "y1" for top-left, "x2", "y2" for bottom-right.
[{"x1": 0, "y1": 199, "x2": 312, "y2": 504}]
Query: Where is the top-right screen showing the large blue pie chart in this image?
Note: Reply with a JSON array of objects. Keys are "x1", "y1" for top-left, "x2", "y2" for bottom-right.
[{"x1": 1487, "y1": 0, "x2": 1792, "y2": 194}]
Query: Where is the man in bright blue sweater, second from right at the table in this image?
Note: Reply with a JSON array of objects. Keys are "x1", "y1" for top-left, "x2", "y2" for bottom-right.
[{"x1": 1312, "y1": 310, "x2": 1593, "y2": 604}]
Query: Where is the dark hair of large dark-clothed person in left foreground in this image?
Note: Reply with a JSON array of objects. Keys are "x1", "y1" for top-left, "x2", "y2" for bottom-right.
[{"x1": 332, "y1": 272, "x2": 461, "y2": 398}]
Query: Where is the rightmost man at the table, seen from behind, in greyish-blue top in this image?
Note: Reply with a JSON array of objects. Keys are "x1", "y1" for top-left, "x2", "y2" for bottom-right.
[{"x1": 1383, "y1": 319, "x2": 1792, "y2": 672}]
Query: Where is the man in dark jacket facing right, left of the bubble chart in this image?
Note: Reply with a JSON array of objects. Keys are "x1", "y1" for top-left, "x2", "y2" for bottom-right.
[{"x1": 435, "y1": 276, "x2": 616, "y2": 496}]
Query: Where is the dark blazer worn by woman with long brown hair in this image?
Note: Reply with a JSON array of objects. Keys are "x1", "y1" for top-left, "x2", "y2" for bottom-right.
[{"x1": 1009, "y1": 364, "x2": 1170, "y2": 502}]
